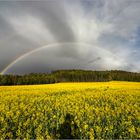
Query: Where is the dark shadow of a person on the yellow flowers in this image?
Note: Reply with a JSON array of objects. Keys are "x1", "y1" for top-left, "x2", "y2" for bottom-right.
[{"x1": 58, "y1": 113, "x2": 80, "y2": 139}]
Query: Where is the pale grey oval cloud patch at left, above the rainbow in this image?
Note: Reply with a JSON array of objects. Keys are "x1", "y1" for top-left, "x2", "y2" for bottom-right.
[{"x1": 9, "y1": 15, "x2": 55, "y2": 43}]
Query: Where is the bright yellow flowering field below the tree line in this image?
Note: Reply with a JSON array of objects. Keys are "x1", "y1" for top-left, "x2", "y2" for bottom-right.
[{"x1": 0, "y1": 82, "x2": 140, "y2": 139}]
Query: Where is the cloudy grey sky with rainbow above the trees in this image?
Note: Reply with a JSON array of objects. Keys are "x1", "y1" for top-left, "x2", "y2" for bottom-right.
[{"x1": 0, "y1": 0, "x2": 140, "y2": 74}]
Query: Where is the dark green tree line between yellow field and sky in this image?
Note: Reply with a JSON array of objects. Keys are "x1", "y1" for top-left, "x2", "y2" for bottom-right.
[{"x1": 0, "y1": 70, "x2": 140, "y2": 85}]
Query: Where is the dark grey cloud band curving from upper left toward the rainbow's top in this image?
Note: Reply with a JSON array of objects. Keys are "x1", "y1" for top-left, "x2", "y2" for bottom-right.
[{"x1": 0, "y1": 1, "x2": 75, "y2": 42}]
